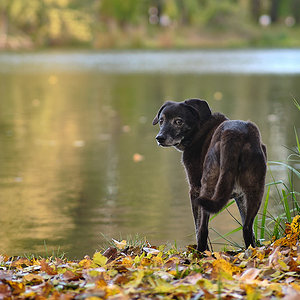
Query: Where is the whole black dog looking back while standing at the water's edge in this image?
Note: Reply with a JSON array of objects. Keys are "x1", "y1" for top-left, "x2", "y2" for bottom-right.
[{"x1": 153, "y1": 99, "x2": 267, "y2": 251}]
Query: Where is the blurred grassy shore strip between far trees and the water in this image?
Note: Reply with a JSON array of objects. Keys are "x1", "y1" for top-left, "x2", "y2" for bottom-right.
[{"x1": 0, "y1": 26, "x2": 300, "y2": 52}]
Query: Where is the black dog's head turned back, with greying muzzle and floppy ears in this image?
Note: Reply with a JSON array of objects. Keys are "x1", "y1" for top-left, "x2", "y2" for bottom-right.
[{"x1": 152, "y1": 99, "x2": 211, "y2": 150}]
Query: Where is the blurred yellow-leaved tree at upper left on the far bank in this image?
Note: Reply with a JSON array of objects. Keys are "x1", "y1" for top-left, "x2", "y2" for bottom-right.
[{"x1": 0, "y1": 0, "x2": 95, "y2": 46}]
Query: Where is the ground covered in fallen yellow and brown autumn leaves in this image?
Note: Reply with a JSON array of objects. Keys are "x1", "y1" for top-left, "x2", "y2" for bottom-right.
[{"x1": 0, "y1": 216, "x2": 300, "y2": 299}]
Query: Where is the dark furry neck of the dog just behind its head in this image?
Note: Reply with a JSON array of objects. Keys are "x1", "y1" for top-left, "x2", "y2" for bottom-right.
[{"x1": 176, "y1": 113, "x2": 228, "y2": 152}]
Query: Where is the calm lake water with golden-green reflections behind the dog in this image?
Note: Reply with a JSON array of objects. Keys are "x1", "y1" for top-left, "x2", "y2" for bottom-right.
[{"x1": 0, "y1": 50, "x2": 300, "y2": 258}]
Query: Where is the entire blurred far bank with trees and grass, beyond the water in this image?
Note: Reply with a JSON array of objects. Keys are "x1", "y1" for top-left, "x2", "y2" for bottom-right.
[{"x1": 0, "y1": 0, "x2": 300, "y2": 49}]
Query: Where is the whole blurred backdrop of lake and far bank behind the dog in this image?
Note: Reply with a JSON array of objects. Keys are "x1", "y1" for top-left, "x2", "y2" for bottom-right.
[{"x1": 0, "y1": 0, "x2": 300, "y2": 258}]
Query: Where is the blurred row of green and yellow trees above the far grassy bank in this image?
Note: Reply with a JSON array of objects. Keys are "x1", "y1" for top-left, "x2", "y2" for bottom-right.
[{"x1": 0, "y1": 0, "x2": 300, "y2": 48}]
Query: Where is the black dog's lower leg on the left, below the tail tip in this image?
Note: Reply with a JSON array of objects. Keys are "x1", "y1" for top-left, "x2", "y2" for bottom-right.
[{"x1": 190, "y1": 190, "x2": 209, "y2": 252}]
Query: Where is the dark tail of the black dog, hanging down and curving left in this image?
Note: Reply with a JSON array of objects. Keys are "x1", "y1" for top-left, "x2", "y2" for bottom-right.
[{"x1": 197, "y1": 130, "x2": 243, "y2": 213}]
